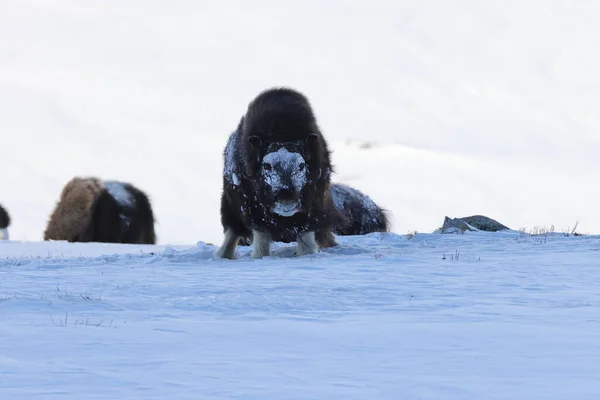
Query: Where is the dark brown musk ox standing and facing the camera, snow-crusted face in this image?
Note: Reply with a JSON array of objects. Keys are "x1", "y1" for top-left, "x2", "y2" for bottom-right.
[{"x1": 216, "y1": 88, "x2": 346, "y2": 259}]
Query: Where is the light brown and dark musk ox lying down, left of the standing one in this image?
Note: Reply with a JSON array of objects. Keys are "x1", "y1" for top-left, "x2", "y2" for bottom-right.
[{"x1": 44, "y1": 177, "x2": 156, "y2": 244}]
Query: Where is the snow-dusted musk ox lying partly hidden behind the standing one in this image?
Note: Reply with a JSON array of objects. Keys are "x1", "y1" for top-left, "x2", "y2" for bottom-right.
[{"x1": 330, "y1": 183, "x2": 389, "y2": 236}]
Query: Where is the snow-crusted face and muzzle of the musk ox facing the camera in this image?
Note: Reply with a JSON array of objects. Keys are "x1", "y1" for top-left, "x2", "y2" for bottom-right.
[{"x1": 260, "y1": 147, "x2": 308, "y2": 217}]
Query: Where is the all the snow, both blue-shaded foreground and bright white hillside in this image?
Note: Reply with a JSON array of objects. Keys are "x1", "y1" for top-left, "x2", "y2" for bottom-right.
[{"x1": 0, "y1": 0, "x2": 600, "y2": 394}]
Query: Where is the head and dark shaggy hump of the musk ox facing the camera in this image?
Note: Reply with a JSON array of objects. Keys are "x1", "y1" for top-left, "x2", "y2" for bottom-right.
[{"x1": 240, "y1": 88, "x2": 331, "y2": 217}]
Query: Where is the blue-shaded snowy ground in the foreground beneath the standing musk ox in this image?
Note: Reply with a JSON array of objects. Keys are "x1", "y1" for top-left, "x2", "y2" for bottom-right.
[{"x1": 0, "y1": 232, "x2": 600, "y2": 400}]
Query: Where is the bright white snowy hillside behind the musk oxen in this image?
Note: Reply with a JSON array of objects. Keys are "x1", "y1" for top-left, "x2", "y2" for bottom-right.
[{"x1": 0, "y1": 0, "x2": 600, "y2": 244}]
